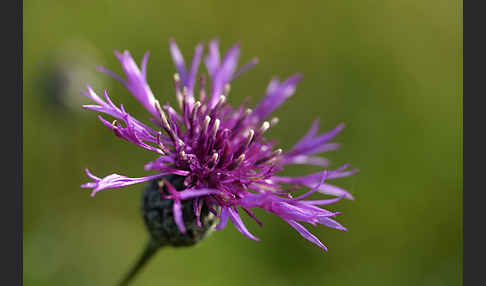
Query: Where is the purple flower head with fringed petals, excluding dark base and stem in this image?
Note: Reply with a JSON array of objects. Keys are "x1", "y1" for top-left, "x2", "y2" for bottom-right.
[{"x1": 82, "y1": 40, "x2": 357, "y2": 250}]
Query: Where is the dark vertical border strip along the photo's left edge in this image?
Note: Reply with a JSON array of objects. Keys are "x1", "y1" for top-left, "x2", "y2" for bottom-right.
[{"x1": 0, "y1": 0, "x2": 23, "y2": 285}]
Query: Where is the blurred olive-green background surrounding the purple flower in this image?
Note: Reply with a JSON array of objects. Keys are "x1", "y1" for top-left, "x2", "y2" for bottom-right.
[{"x1": 23, "y1": 0, "x2": 462, "y2": 286}]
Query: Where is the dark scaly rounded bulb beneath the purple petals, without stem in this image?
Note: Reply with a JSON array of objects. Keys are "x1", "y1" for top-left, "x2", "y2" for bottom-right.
[{"x1": 142, "y1": 175, "x2": 217, "y2": 246}]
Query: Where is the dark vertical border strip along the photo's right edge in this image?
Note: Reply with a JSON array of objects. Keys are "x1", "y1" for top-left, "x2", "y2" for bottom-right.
[{"x1": 464, "y1": 0, "x2": 486, "y2": 285}]
